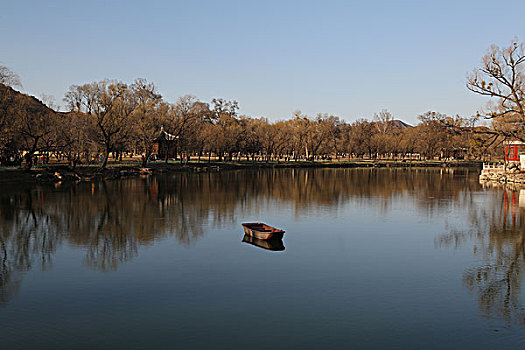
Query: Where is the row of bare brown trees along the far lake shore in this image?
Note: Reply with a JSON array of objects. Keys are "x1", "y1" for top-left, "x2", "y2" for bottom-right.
[{"x1": 0, "y1": 38, "x2": 525, "y2": 182}]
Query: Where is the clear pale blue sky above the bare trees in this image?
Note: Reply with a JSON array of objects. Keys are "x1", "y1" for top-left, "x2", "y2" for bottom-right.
[{"x1": 0, "y1": 0, "x2": 525, "y2": 123}]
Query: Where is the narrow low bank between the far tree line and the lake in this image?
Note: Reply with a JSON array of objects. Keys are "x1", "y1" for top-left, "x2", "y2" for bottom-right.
[{"x1": 0, "y1": 160, "x2": 483, "y2": 185}]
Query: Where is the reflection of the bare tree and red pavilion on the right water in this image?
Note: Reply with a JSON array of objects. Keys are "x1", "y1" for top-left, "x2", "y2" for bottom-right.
[{"x1": 439, "y1": 188, "x2": 525, "y2": 325}]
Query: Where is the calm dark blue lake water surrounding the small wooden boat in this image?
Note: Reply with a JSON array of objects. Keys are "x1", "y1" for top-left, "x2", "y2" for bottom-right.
[{"x1": 0, "y1": 169, "x2": 525, "y2": 349}]
